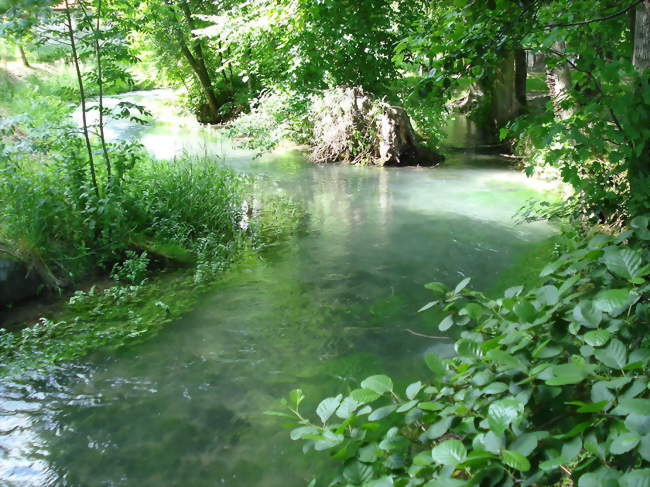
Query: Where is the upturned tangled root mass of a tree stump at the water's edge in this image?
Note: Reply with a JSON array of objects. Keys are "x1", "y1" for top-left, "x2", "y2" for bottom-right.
[{"x1": 311, "y1": 88, "x2": 442, "y2": 166}]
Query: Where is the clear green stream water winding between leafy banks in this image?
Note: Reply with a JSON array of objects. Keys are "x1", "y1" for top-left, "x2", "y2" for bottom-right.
[{"x1": 0, "y1": 92, "x2": 552, "y2": 487}]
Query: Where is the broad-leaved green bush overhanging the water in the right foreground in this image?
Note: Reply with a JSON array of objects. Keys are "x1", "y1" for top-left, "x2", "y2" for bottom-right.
[{"x1": 274, "y1": 217, "x2": 650, "y2": 487}]
